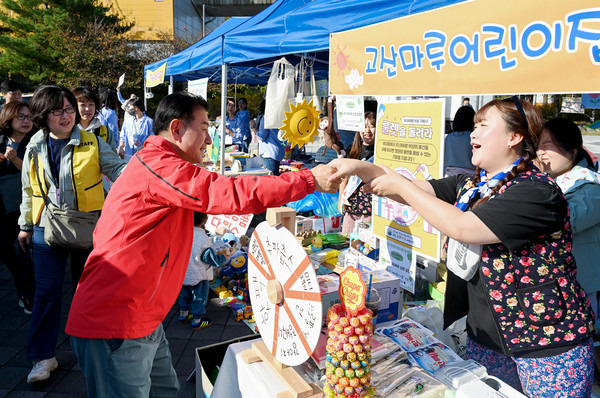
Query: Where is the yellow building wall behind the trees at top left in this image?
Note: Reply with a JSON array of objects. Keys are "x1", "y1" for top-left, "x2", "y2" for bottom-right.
[{"x1": 103, "y1": 0, "x2": 176, "y2": 40}]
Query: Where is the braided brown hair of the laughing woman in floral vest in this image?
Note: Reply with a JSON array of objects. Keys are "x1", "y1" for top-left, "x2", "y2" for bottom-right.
[{"x1": 469, "y1": 97, "x2": 544, "y2": 208}]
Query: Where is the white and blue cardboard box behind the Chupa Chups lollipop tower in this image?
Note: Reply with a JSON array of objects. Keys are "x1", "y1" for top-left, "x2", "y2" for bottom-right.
[{"x1": 317, "y1": 268, "x2": 401, "y2": 323}]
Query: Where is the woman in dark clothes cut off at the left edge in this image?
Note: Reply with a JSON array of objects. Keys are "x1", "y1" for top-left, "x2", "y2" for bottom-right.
[{"x1": 0, "y1": 101, "x2": 35, "y2": 314}]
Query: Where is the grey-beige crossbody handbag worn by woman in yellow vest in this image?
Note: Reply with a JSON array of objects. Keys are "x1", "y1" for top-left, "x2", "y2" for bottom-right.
[{"x1": 33, "y1": 153, "x2": 100, "y2": 249}]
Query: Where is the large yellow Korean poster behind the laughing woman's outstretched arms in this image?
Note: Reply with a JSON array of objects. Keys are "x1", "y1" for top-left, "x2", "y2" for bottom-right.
[{"x1": 373, "y1": 99, "x2": 445, "y2": 261}]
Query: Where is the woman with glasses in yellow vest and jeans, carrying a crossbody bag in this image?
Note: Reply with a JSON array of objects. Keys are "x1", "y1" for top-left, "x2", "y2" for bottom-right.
[{"x1": 19, "y1": 85, "x2": 125, "y2": 383}]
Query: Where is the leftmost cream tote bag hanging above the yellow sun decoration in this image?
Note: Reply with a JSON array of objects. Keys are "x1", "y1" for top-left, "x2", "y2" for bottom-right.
[{"x1": 265, "y1": 58, "x2": 295, "y2": 129}]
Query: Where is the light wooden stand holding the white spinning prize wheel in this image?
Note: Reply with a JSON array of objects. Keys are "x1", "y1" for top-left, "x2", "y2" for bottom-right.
[{"x1": 241, "y1": 207, "x2": 323, "y2": 398}]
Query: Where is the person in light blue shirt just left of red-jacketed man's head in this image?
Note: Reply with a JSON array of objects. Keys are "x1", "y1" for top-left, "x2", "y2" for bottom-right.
[{"x1": 118, "y1": 97, "x2": 153, "y2": 158}]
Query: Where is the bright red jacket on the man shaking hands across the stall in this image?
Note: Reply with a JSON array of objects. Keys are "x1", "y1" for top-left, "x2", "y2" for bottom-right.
[{"x1": 66, "y1": 136, "x2": 314, "y2": 339}]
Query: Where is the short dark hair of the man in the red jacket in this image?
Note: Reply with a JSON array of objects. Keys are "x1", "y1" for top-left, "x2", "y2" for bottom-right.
[{"x1": 152, "y1": 91, "x2": 208, "y2": 135}]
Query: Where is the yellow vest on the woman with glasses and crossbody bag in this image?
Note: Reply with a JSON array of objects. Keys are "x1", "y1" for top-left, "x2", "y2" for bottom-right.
[{"x1": 29, "y1": 130, "x2": 104, "y2": 224}]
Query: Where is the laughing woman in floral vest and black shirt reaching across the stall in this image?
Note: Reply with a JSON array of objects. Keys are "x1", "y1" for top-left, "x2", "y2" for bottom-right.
[{"x1": 330, "y1": 97, "x2": 594, "y2": 397}]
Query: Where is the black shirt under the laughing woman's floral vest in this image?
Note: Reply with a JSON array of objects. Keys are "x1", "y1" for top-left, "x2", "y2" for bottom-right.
[{"x1": 430, "y1": 174, "x2": 576, "y2": 357}]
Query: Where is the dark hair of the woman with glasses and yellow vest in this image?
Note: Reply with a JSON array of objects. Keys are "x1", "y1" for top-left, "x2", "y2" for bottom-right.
[{"x1": 29, "y1": 84, "x2": 81, "y2": 133}]
